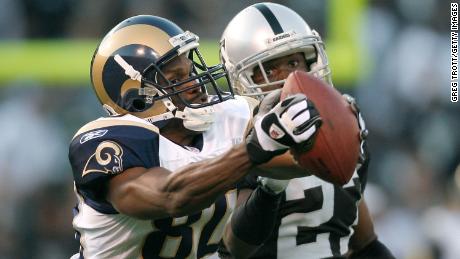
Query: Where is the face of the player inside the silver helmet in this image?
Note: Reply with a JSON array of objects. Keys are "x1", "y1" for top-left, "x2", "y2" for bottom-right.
[{"x1": 252, "y1": 53, "x2": 308, "y2": 91}]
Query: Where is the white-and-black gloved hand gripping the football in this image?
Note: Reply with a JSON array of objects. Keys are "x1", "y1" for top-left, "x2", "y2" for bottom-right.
[{"x1": 246, "y1": 90, "x2": 321, "y2": 164}]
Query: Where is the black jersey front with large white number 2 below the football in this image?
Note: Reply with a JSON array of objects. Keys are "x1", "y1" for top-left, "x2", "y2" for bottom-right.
[{"x1": 251, "y1": 173, "x2": 362, "y2": 259}]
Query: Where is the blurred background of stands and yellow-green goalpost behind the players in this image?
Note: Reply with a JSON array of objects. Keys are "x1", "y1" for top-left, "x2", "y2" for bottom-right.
[{"x1": 0, "y1": 0, "x2": 460, "y2": 259}]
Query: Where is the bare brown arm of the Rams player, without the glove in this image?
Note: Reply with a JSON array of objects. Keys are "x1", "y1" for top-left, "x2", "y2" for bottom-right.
[{"x1": 107, "y1": 144, "x2": 252, "y2": 219}]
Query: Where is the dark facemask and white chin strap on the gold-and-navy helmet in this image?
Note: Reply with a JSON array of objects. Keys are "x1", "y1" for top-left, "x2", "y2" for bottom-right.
[{"x1": 115, "y1": 31, "x2": 233, "y2": 128}]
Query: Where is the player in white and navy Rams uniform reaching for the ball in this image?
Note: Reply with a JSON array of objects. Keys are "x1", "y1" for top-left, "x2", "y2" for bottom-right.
[{"x1": 69, "y1": 15, "x2": 321, "y2": 259}]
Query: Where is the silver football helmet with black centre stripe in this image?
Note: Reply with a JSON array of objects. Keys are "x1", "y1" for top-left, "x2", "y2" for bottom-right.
[{"x1": 220, "y1": 3, "x2": 332, "y2": 96}]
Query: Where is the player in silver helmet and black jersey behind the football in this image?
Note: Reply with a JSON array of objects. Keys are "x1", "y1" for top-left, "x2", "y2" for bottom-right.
[{"x1": 220, "y1": 3, "x2": 393, "y2": 259}]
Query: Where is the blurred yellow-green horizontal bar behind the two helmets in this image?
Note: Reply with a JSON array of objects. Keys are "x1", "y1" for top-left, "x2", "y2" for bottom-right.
[{"x1": 0, "y1": 40, "x2": 359, "y2": 87}]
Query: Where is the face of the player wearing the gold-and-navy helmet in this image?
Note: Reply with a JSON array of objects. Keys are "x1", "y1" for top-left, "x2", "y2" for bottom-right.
[{"x1": 159, "y1": 55, "x2": 208, "y2": 110}]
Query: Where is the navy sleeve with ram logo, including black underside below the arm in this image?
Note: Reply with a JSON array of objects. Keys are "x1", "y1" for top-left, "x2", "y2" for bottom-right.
[{"x1": 69, "y1": 120, "x2": 160, "y2": 213}]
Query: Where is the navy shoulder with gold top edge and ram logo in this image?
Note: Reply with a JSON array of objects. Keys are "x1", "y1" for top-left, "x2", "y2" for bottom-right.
[{"x1": 69, "y1": 117, "x2": 159, "y2": 185}]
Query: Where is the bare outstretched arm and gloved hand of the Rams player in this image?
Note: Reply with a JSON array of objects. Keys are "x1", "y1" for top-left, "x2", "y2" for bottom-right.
[{"x1": 107, "y1": 92, "x2": 319, "y2": 219}]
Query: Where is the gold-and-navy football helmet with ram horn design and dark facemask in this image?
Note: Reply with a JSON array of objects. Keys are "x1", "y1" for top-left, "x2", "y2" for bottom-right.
[{"x1": 91, "y1": 15, "x2": 233, "y2": 125}]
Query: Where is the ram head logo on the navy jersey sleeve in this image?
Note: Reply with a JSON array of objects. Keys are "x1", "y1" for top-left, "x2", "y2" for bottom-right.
[{"x1": 82, "y1": 141, "x2": 123, "y2": 177}]
